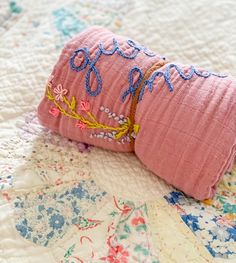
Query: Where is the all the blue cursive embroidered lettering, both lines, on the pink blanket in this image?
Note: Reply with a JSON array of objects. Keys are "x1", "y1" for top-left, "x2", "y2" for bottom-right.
[{"x1": 70, "y1": 38, "x2": 227, "y2": 102}]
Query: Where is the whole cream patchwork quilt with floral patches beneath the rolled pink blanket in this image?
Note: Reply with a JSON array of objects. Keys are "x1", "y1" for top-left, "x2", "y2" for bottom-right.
[{"x1": 0, "y1": 0, "x2": 236, "y2": 263}]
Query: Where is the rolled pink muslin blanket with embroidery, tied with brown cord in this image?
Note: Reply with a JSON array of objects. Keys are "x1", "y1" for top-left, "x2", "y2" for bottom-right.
[{"x1": 38, "y1": 27, "x2": 236, "y2": 200}]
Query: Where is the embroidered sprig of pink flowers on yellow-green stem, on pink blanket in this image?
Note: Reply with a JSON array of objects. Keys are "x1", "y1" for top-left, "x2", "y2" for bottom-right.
[{"x1": 46, "y1": 81, "x2": 139, "y2": 139}]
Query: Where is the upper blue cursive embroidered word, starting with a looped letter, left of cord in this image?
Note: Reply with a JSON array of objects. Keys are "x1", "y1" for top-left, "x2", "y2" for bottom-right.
[{"x1": 69, "y1": 38, "x2": 156, "y2": 97}]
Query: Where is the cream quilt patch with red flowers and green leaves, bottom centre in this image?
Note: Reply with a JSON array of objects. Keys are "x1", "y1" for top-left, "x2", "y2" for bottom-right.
[{"x1": 100, "y1": 198, "x2": 159, "y2": 263}]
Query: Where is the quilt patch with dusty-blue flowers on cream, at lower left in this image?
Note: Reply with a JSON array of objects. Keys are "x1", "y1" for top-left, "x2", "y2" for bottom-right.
[{"x1": 14, "y1": 180, "x2": 106, "y2": 247}]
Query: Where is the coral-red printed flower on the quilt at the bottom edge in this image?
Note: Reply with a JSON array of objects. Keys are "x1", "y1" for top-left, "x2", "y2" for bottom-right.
[{"x1": 100, "y1": 245, "x2": 129, "y2": 263}]
